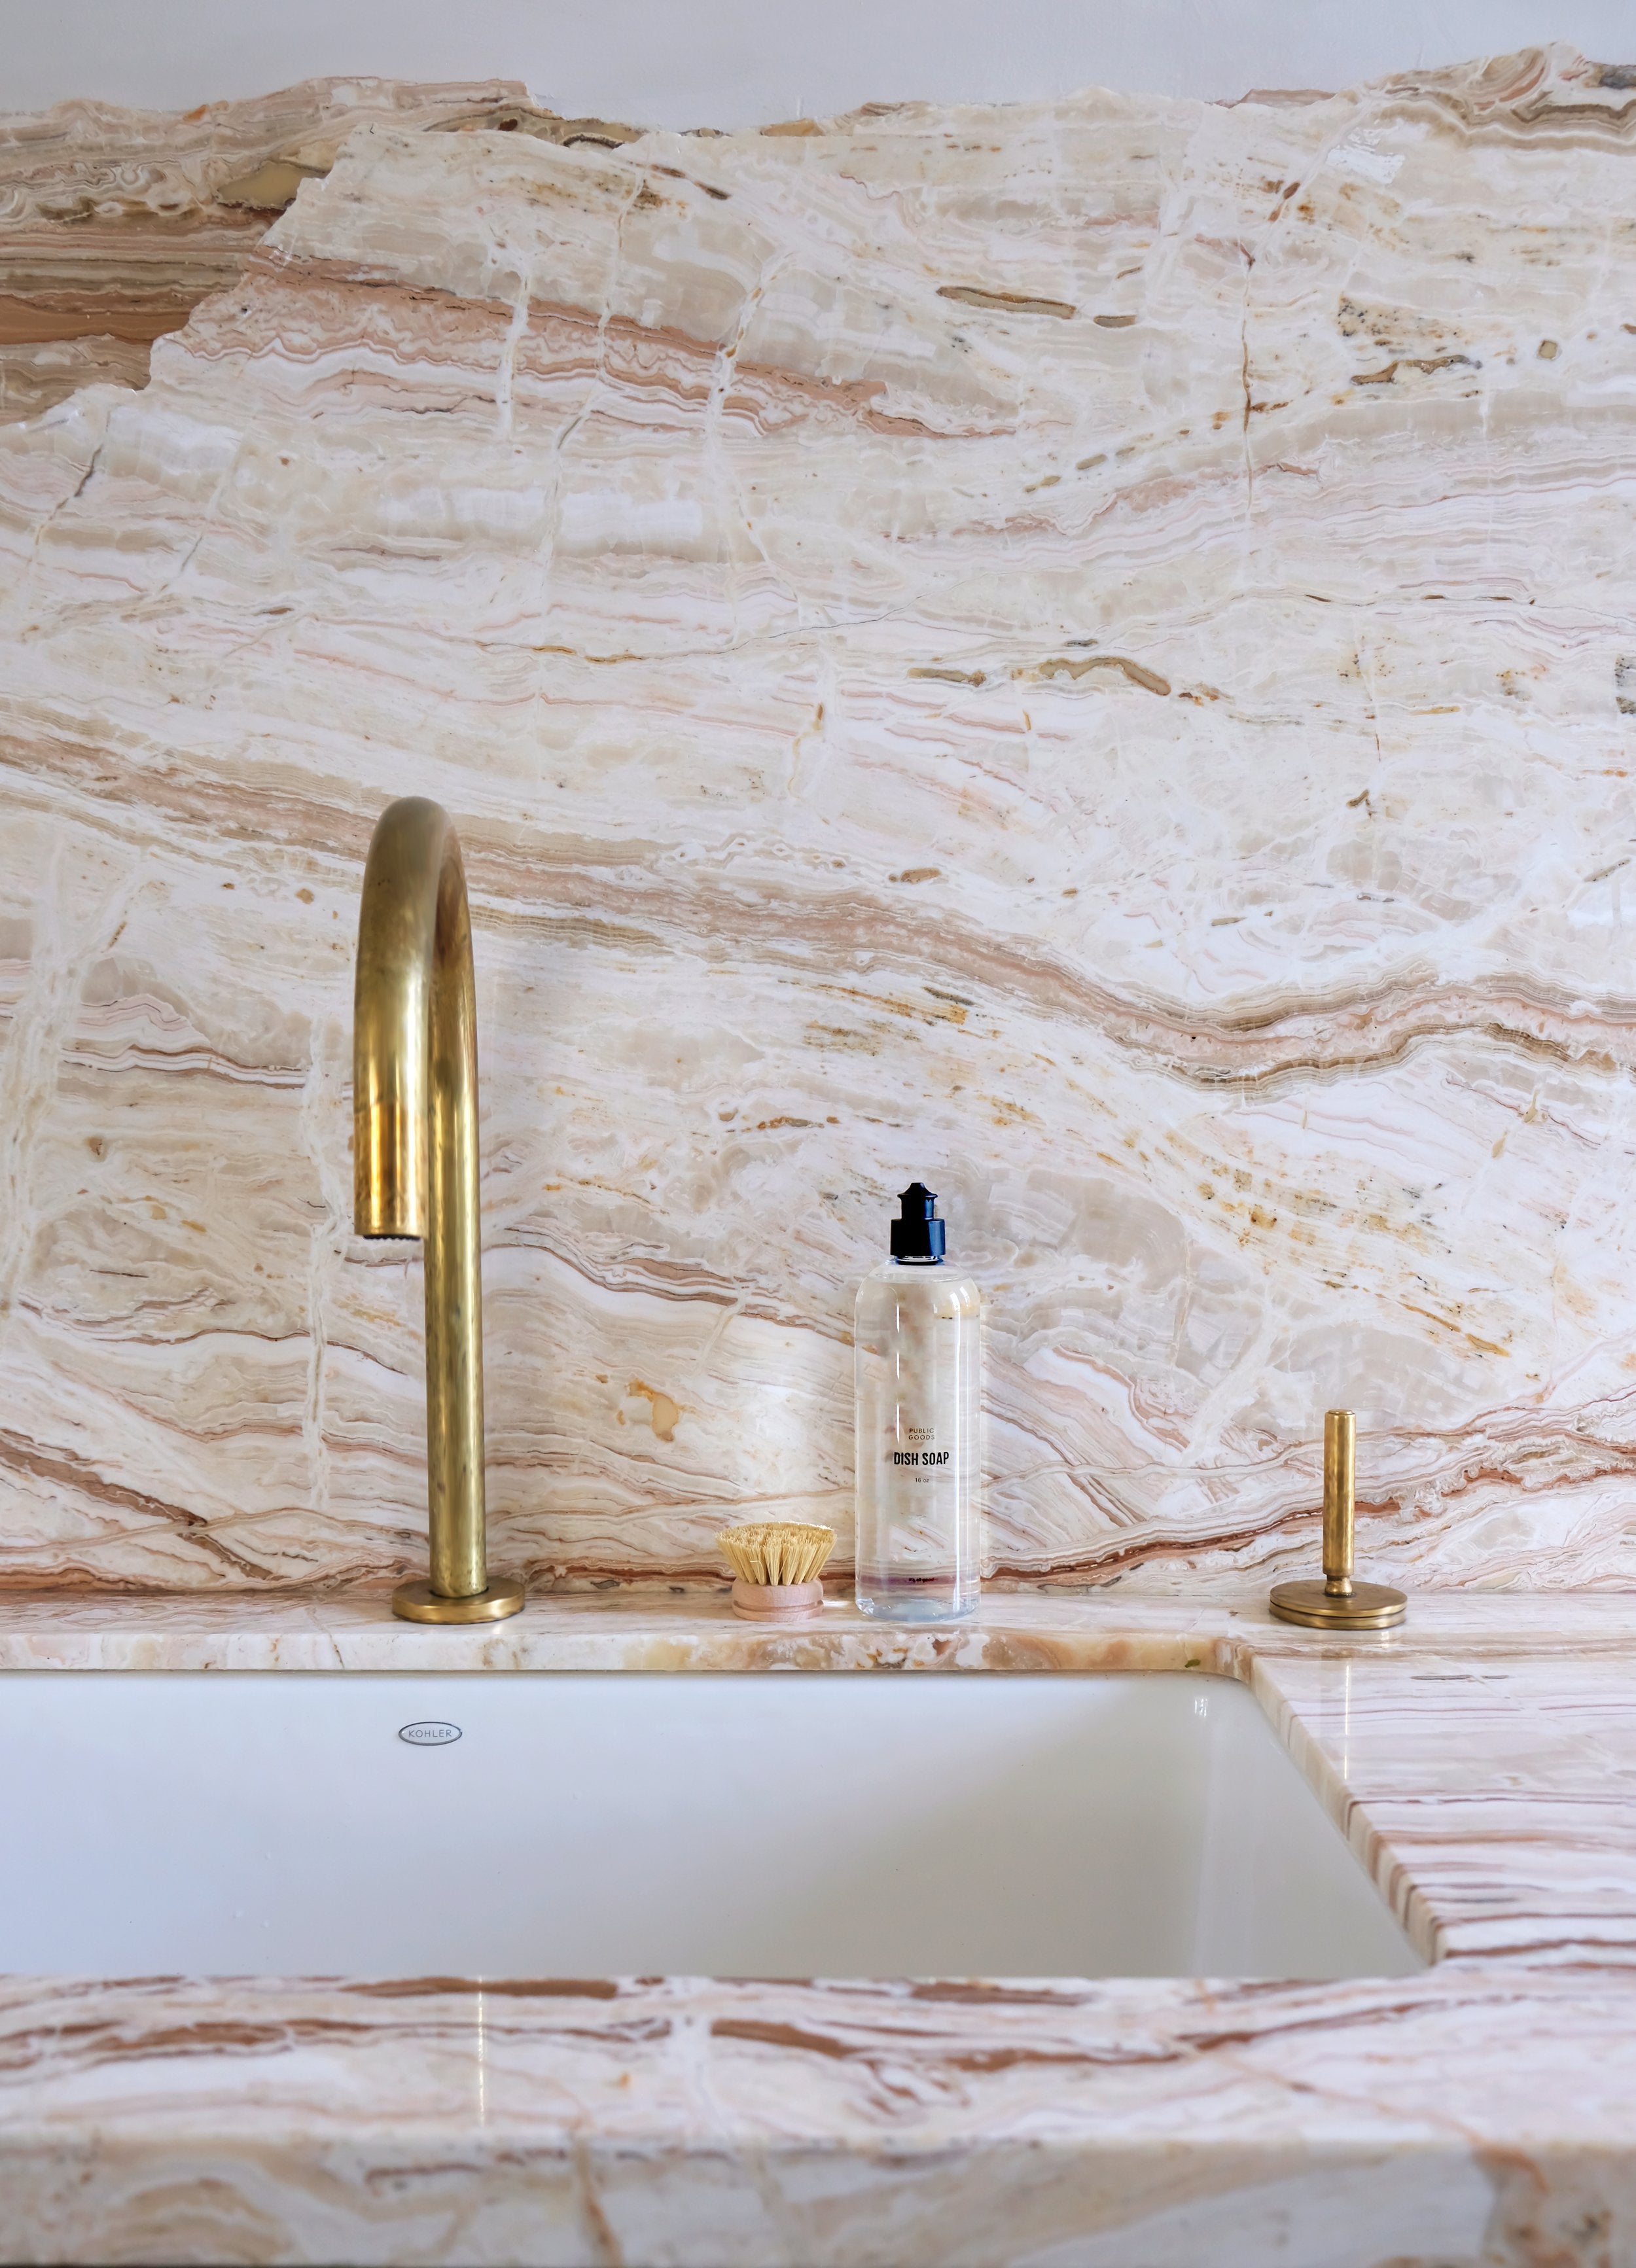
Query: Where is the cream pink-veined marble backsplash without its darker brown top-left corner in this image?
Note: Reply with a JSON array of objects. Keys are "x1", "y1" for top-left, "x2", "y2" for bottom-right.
[{"x1": 0, "y1": 48, "x2": 1636, "y2": 1587}]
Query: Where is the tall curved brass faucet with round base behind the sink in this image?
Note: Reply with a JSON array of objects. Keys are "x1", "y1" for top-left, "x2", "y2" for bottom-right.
[{"x1": 351, "y1": 796, "x2": 524, "y2": 1621}]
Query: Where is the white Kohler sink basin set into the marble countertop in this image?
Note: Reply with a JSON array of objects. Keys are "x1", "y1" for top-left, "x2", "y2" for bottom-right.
[{"x1": 0, "y1": 1671, "x2": 1421, "y2": 1977}]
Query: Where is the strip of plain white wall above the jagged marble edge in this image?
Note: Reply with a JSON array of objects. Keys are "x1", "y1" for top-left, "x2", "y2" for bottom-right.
[{"x1": 0, "y1": 0, "x2": 1636, "y2": 127}]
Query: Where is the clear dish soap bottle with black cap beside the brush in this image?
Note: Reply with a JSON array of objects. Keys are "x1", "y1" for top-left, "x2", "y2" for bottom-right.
[{"x1": 853, "y1": 1182, "x2": 982, "y2": 1621}]
